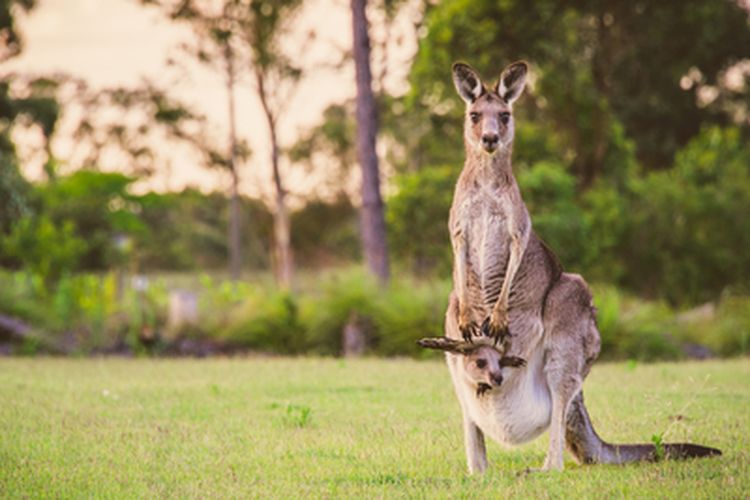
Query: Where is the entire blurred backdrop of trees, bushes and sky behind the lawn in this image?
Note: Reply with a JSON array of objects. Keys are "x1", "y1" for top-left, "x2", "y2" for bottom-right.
[{"x1": 0, "y1": 0, "x2": 750, "y2": 360}]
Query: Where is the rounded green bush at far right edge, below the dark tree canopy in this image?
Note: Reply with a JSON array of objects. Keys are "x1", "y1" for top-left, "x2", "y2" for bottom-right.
[{"x1": 621, "y1": 127, "x2": 750, "y2": 304}]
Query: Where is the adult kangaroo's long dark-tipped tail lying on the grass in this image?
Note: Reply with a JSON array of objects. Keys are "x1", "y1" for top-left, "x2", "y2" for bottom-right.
[{"x1": 565, "y1": 393, "x2": 721, "y2": 464}]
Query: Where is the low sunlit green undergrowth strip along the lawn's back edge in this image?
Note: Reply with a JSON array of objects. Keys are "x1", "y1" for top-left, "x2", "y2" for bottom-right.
[{"x1": 0, "y1": 270, "x2": 750, "y2": 361}]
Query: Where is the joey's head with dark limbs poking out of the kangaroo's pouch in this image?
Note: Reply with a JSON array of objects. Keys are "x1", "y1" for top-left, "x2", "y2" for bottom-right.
[{"x1": 417, "y1": 337, "x2": 526, "y2": 395}]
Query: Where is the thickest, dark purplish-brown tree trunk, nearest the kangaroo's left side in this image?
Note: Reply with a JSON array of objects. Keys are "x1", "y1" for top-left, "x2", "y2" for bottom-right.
[{"x1": 351, "y1": 0, "x2": 390, "y2": 284}]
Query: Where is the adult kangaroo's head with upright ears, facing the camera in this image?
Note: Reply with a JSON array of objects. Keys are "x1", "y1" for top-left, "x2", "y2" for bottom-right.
[{"x1": 453, "y1": 61, "x2": 528, "y2": 156}]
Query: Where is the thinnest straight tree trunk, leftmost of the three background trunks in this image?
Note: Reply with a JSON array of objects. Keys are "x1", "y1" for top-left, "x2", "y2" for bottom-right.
[{"x1": 224, "y1": 43, "x2": 242, "y2": 281}]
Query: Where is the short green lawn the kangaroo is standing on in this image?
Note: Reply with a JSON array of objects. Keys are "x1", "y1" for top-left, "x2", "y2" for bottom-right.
[{"x1": 0, "y1": 358, "x2": 750, "y2": 498}]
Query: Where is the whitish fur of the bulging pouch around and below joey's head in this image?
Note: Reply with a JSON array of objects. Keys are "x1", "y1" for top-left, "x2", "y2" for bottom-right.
[{"x1": 449, "y1": 350, "x2": 552, "y2": 445}]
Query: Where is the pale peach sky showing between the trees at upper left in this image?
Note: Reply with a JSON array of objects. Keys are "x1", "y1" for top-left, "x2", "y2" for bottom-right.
[{"x1": 2, "y1": 0, "x2": 415, "y2": 197}]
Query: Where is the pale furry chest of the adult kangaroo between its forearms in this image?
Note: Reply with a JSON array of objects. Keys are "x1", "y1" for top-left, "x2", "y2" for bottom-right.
[{"x1": 451, "y1": 187, "x2": 513, "y2": 307}]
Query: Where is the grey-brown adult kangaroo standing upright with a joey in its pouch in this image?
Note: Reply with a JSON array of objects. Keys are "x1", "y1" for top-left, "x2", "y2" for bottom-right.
[{"x1": 420, "y1": 62, "x2": 721, "y2": 473}]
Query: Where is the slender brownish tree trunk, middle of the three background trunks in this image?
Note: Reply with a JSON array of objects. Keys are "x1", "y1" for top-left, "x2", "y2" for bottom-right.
[{"x1": 256, "y1": 71, "x2": 294, "y2": 290}]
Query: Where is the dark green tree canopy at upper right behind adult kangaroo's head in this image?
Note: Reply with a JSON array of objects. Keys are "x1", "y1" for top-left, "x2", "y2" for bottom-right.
[{"x1": 404, "y1": 0, "x2": 750, "y2": 178}]
